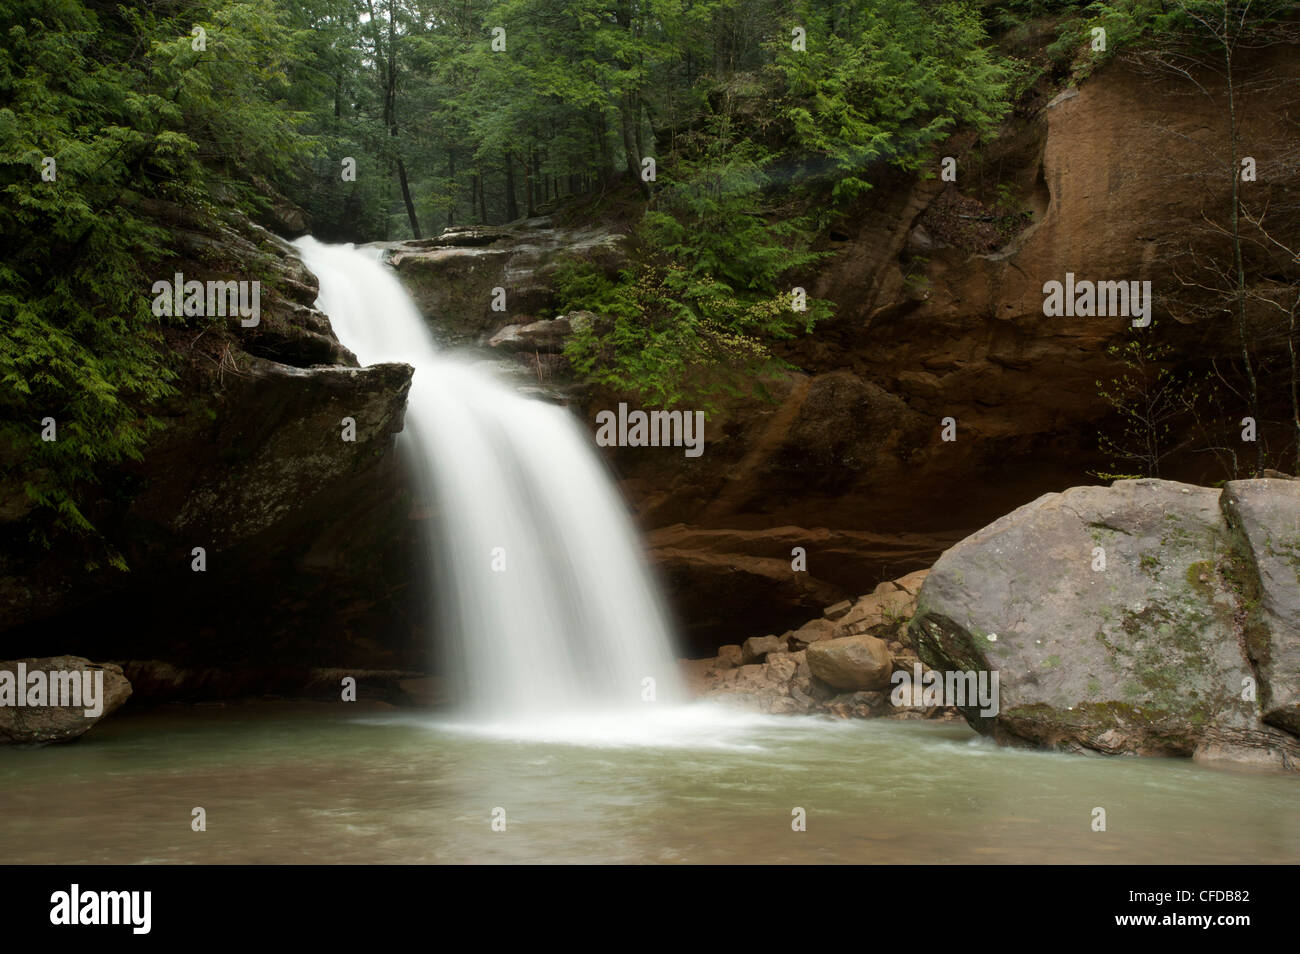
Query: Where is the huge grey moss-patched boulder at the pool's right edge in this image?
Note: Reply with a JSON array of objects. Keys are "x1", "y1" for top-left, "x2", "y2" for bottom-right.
[{"x1": 910, "y1": 480, "x2": 1300, "y2": 768}]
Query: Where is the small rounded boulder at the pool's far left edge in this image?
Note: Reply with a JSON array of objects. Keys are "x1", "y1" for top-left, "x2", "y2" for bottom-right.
[{"x1": 0, "y1": 656, "x2": 131, "y2": 745}]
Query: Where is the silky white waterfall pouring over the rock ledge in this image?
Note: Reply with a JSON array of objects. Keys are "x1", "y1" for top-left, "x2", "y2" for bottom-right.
[{"x1": 296, "y1": 237, "x2": 681, "y2": 734}]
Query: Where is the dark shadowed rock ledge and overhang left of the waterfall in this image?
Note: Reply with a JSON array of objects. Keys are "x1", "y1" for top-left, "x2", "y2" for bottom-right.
[{"x1": 0, "y1": 209, "x2": 428, "y2": 691}]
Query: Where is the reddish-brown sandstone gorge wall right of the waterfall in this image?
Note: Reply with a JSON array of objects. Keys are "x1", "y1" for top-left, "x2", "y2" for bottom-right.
[{"x1": 391, "y1": 49, "x2": 1300, "y2": 649}]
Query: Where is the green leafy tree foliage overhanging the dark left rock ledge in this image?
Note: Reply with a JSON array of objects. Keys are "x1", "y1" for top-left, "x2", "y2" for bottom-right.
[{"x1": 0, "y1": 0, "x2": 310, "y2": 567}]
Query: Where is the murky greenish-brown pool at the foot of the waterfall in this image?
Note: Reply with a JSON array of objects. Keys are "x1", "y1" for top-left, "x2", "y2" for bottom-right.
[{"x1": 0, "y1": 703, "x2": 1300, "y2": 863}]
